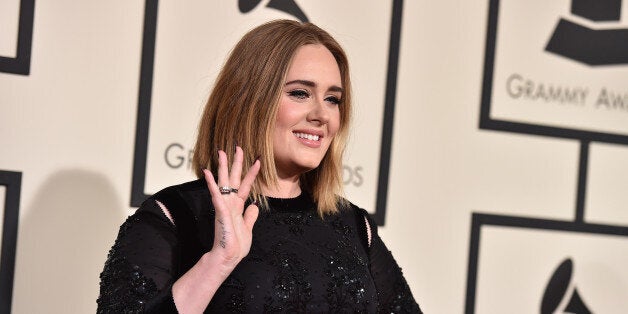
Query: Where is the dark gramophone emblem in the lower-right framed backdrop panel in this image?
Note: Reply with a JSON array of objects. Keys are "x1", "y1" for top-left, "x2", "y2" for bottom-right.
[{"x1": 541, "y1": 258, "x2": 591, "y2": 314}]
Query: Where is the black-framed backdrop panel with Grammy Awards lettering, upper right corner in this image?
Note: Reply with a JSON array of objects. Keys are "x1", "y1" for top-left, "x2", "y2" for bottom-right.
[{"x1": 480, "y1": 0, "x2": 628, "y2": 144}]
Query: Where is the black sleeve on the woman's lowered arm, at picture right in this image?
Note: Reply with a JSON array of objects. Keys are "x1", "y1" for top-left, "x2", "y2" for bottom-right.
[{"x1": 365, "y1": 212, "x2": 422, "y2": 313}]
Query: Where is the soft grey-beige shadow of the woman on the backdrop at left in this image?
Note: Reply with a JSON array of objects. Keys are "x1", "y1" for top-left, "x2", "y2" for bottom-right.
[{"x1": 13, "y1": 169, "x2": 126, "y2": 313}]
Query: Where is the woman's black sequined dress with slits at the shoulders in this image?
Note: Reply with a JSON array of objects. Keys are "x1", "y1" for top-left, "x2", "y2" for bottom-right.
[{"x1": 97, "y1": 180, "x2": 421, "y2": 313}]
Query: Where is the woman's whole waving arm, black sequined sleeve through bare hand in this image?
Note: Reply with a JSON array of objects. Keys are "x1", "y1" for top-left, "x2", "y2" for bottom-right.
[{"x1": 97, "y1": 148, "x2": 259, "y2": 313}]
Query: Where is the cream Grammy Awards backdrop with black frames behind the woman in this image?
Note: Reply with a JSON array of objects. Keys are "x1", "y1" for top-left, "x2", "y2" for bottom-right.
[{"x1": 0, "y1": 0, "x2": 628, "y2": 314}]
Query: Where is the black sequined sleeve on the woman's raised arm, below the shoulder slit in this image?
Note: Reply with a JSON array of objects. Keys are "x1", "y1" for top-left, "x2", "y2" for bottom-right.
[{"x1": 97, "y1": 199, "x2": 179, "y2": 313}]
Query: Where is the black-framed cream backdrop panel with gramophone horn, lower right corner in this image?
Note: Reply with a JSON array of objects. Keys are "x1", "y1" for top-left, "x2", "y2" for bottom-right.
[{"x1": 465, "y1": 213, "x2": 628, "y2": 314}]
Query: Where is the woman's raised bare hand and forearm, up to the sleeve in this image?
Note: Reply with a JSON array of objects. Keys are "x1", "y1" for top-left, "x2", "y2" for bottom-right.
[{"x1": 172, "y1": 147, "x2": 260, "y2": 313}]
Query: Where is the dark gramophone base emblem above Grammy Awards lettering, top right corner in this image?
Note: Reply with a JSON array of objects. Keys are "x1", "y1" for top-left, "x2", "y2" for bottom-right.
[{"x1": 545, "y1": 0, "x2": 628, "y2": 66}]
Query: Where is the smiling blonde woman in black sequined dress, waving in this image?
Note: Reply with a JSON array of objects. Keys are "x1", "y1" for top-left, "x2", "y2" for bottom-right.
[{"x1": 98, "y1": 20, "x2": 420, "y2": 313}]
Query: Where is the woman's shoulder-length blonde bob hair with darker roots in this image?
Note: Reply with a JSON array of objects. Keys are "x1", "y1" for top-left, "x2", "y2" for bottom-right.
[{"x1": 193, "y1": 20, "x2": 351, "y2": 216}]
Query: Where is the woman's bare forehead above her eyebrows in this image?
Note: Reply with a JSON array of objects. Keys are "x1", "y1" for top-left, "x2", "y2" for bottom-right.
[{"x1": 286, "y1": 44, "x2": 341, "y2": 86}]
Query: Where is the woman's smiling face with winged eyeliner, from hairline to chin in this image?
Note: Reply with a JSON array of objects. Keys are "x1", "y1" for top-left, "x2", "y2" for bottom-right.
[{"x1": 273, "y1": 44, "x2": 342, "y2": 178}]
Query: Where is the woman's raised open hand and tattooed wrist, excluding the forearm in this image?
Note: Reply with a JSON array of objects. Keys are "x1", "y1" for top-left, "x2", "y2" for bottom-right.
[{"x1": 203, "y1": 146, "x2": 260, "y2": 268}]
